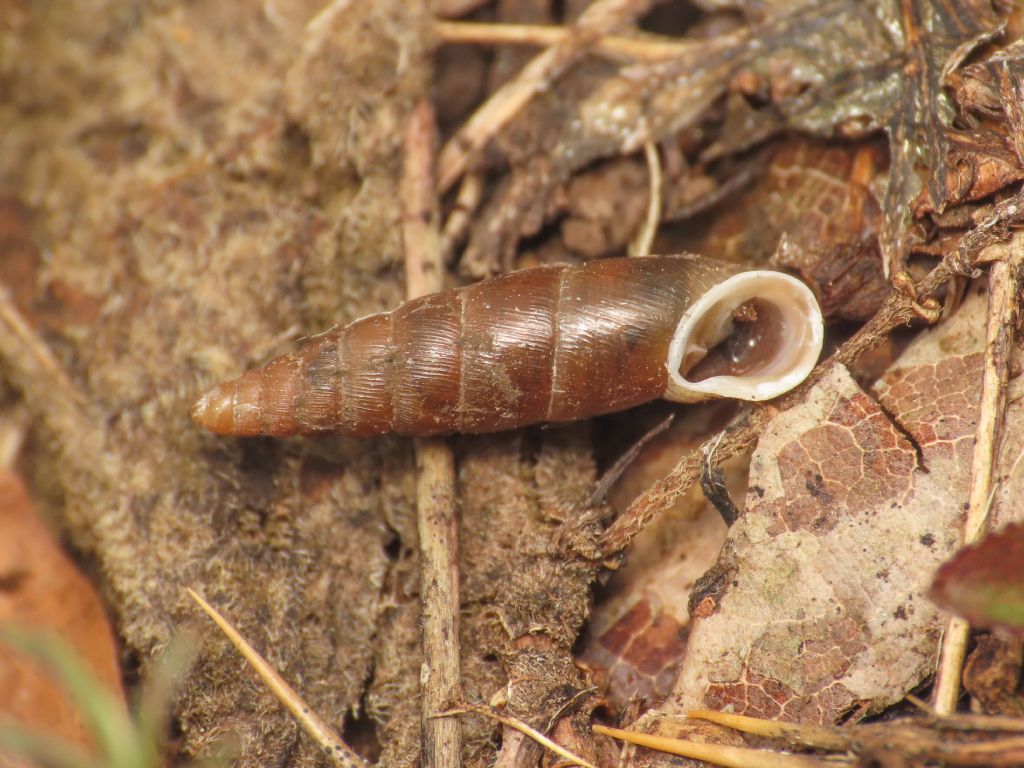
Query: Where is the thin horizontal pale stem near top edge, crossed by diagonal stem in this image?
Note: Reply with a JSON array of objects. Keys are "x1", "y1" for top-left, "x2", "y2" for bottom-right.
[{"x1": 434, "y1": 22, "x2": 693, "y2": 61}]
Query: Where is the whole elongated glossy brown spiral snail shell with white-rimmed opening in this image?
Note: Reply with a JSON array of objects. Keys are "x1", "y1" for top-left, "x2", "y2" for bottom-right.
[{"x1": 191, "y1": 255, "x2": 822, "y2": 436}]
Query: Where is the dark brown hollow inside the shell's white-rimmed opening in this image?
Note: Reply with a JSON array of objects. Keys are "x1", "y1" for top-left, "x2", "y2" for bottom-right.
[{"x1": 680, "y1": 299, "x2": 784, "y2": 382}]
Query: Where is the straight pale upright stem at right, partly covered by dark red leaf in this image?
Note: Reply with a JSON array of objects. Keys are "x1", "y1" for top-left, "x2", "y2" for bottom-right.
[{"x1": 934, "y1": 232, "x2": 1024, "y2": 715}]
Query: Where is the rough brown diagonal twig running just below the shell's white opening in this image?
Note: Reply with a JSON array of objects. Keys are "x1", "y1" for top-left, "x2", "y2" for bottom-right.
[{"x1": 601, "y1": 190, "x2": 1024, "y2": 556}]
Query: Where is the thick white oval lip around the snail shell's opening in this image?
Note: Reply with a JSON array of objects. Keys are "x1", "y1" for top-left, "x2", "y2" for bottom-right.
[{"x1": 665, "y1": 269, "x2": 824, "y2": 402}]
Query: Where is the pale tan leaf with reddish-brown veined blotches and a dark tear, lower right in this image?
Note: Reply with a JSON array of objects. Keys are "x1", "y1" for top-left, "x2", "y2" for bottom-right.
[{"x1": 630, "y1": 287, "x2": 1024, "y2": 745}]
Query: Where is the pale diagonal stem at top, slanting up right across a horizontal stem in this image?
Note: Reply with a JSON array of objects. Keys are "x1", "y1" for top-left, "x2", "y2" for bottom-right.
[{"x1": 437, "y1": 0, "x2": 649, "y2": 195}]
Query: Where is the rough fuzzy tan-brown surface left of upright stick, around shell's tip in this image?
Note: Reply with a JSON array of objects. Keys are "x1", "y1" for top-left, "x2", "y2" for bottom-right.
[{"x1": 0, "y1": 0, "x2": 429, "y2": 765}]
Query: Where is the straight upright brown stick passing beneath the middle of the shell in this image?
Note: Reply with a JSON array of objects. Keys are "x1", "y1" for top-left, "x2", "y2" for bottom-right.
[{"x1": 401, "y1": 99, "x2": 462, "y2": 768}]
